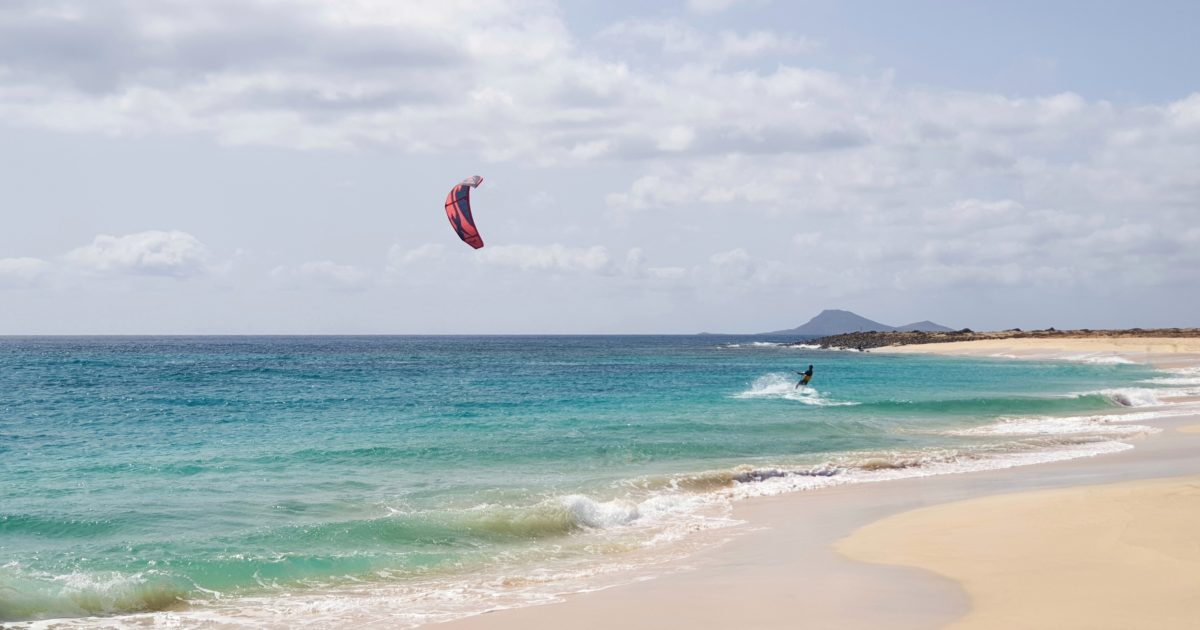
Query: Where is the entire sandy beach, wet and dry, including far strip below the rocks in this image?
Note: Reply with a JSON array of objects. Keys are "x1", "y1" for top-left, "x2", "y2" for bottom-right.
[{"x1": 437, "y1": 338, "x2": 1200, "y2": 629}]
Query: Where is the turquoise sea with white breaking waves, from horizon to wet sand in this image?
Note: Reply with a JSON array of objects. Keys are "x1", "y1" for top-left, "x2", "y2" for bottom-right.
[{"x1": 0, "y1": 336, "x2": 1180, "y2": 622}]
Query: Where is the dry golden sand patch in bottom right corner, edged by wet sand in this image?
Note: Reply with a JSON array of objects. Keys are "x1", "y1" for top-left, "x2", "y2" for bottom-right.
[{"x1": 838, "y1": 476, "x2": 1200, "y2": 629}]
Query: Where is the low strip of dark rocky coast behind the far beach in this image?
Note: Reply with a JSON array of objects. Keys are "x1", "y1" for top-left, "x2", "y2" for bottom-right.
[{"x1": 796, "y1": 328, "x2": 1200, "y2": 350}]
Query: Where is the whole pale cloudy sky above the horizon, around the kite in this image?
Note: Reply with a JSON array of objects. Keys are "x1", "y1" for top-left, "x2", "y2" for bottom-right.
[{"x1": 0, "y1": 0, "x2": 1200, "y2": 335}]
